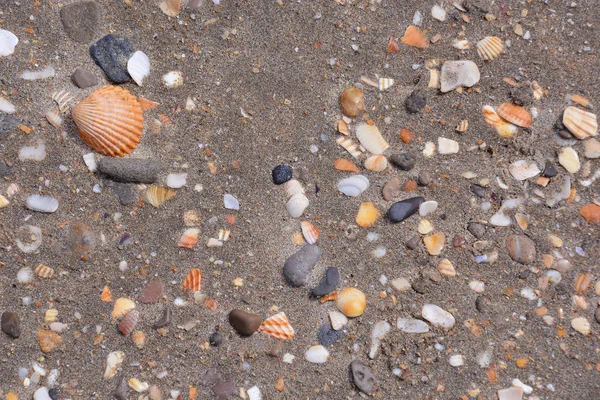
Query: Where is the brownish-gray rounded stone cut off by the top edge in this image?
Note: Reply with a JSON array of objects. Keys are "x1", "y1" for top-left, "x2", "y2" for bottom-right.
[{"x1": 60, "y1": 1, "x2": 100, "y2": 43}]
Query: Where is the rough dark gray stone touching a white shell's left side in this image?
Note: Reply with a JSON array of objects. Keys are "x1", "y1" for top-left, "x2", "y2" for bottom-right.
[{"x1": 90, "y1": 34, "x2": 135, "y2": 83}]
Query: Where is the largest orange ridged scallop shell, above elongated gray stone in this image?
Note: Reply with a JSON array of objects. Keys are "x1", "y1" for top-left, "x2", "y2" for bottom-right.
[{"x1": 72, "y1": 86, "x2": 144, "y2": 157}]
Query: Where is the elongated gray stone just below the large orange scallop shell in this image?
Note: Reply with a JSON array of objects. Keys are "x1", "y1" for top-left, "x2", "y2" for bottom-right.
[{"x1": 98, "y1": 157, "x2": 161, "y2": 183}]
